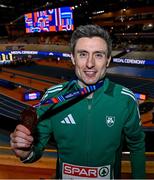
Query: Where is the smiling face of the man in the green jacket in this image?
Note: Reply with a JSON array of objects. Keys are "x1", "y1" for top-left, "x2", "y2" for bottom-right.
[{"x1": 72, "y1": 37, "x2": 111, "y2": 86}]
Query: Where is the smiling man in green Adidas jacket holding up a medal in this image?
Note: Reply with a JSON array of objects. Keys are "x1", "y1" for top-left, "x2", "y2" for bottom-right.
[{"x1": 10, "y1": 25, "x2": 145, "y2": 179}]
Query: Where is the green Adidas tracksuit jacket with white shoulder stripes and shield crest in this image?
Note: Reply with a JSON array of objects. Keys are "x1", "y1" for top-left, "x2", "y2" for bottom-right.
[{"x1": 24, "y1": 79, "x2": 145, "y2": 179}]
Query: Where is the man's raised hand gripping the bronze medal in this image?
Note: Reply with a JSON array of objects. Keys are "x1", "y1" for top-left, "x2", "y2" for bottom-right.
[{"x1": 10, "y1": 124, "x2": 34, "y2": 159}]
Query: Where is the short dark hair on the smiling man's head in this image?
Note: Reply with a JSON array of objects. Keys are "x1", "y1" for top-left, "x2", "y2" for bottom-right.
[{"x1": 70, "y1": 24, "x2": 112, "y2": 58}]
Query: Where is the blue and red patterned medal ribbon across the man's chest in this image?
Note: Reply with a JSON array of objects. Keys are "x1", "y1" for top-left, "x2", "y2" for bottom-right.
[{"x1": 33, "y1": 81, "x2": 103, "y2": 107}]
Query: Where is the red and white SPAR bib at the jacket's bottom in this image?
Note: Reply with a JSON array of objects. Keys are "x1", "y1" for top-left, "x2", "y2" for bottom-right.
[{"x1": 62, "y1": 163, "x2": 110, "y2": 179}]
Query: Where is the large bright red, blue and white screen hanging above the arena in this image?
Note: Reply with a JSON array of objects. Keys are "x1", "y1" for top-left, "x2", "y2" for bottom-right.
[{"x1": 25, "y1": 7, "x2": 74, "y2": 33}]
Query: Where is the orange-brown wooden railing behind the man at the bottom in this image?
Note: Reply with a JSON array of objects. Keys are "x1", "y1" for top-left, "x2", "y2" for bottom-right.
[{"x1": 0, "y1": 146, "x2": 154, "y2": 179}]
